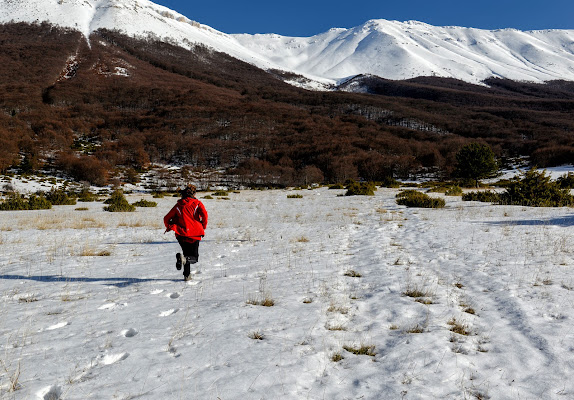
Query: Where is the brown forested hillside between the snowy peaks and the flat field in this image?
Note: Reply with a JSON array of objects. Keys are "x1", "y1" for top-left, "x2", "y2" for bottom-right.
[{"x1": 0, "y1": 23, "x2": 574, "y2": 184}]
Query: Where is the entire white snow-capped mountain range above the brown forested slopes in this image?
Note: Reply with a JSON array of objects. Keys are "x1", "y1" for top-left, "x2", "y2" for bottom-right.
[{"x1": 0, "y1": 0, "x2": 574, "y2": 83}]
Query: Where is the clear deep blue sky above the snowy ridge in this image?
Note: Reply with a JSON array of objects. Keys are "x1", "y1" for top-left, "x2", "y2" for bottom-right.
[{"x1": 152, "y1": 0, "x2": 574, "y2": 36}]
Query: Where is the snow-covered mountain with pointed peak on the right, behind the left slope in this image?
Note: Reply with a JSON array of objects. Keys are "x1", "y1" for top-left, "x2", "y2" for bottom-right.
[{"x1": 235, "y1": 20, "x2": 574, "y2": 82}]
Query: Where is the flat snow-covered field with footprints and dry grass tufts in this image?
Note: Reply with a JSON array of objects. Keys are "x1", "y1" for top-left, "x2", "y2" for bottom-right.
[{"x1": 0, "y1": 189, "x2": 574, "y2": 400}]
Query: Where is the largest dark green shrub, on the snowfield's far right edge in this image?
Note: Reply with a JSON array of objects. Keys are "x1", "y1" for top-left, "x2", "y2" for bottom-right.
[{"x1": 500, "y1": 169, "x2": 574, "y2": 207}]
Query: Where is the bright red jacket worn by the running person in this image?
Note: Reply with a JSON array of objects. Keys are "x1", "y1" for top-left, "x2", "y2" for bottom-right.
[{"x1": 163, "y1": 197, "x2": 207, "y2": 241}]
